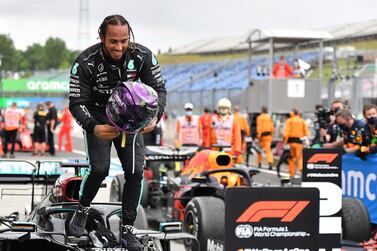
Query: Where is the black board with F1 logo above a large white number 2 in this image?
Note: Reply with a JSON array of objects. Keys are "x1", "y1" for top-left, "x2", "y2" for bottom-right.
[{"x1": 301, "y1": 149, "x2": 342, "y2": 250}]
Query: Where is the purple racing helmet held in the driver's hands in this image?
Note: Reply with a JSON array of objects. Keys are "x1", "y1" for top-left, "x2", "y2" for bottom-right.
[{"x1": 106, "y1": 82, "x2": 158, "y2": 133}]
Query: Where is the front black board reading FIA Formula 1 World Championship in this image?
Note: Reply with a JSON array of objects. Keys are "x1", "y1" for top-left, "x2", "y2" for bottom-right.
[{"x1": 225, "y1": 187, "x2": 319, "y2": 251}]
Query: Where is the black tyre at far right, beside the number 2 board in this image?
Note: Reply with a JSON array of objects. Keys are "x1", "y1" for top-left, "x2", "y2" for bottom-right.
[{"x1": 342, "y1": 197, "x2": 371, "y2": 242}]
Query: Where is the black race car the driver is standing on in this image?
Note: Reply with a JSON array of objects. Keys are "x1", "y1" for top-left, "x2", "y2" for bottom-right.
[{"x1": 0, "y1": 162, "x2": 199, "y2": 251}]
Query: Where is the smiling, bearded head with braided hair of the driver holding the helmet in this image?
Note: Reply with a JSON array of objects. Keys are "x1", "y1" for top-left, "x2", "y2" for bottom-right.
[{"x1": 98, "y1": 15, "x2": 134, "y2": 61}]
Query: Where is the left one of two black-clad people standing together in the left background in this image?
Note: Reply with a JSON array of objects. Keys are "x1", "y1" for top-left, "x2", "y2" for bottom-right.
[{"x1": 33, "y1": 104, "x2": 47, "y2": 156}]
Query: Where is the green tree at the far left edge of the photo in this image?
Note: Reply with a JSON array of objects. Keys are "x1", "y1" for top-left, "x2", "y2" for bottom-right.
[{"x1": 0, "y1": 34, "x2": 19, "y2": 71}]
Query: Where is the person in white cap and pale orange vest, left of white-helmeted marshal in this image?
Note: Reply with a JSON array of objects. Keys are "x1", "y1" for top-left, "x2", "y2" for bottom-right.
[{"x1": 174, "y1": 103, "x2": 203, "y2": 147}]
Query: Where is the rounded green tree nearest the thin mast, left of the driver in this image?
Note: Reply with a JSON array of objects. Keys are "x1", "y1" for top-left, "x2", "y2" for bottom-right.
[{"x1": 43, "y1": 38, "x2": 67, "y2": 70}]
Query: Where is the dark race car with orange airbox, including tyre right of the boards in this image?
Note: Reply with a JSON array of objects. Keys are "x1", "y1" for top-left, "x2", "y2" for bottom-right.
[{"x1": 145, "y1": 146, "x2": 371, "y2": 250}]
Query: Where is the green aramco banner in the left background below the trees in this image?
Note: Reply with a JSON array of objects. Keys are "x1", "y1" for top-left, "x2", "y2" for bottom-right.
[{"x1": 1, "y1": 79, "x2": 69, "y2": 93}]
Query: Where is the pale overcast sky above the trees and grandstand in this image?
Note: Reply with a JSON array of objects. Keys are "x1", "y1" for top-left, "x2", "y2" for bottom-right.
[{"x1": 0, "y1": 0, "x2": 377, "y2": 52}]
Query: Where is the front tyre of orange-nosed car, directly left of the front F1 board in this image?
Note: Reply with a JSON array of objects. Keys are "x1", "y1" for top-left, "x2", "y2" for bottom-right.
[{"x1": 183, "y1": 196, "x2": 225, "y2": 251}]
